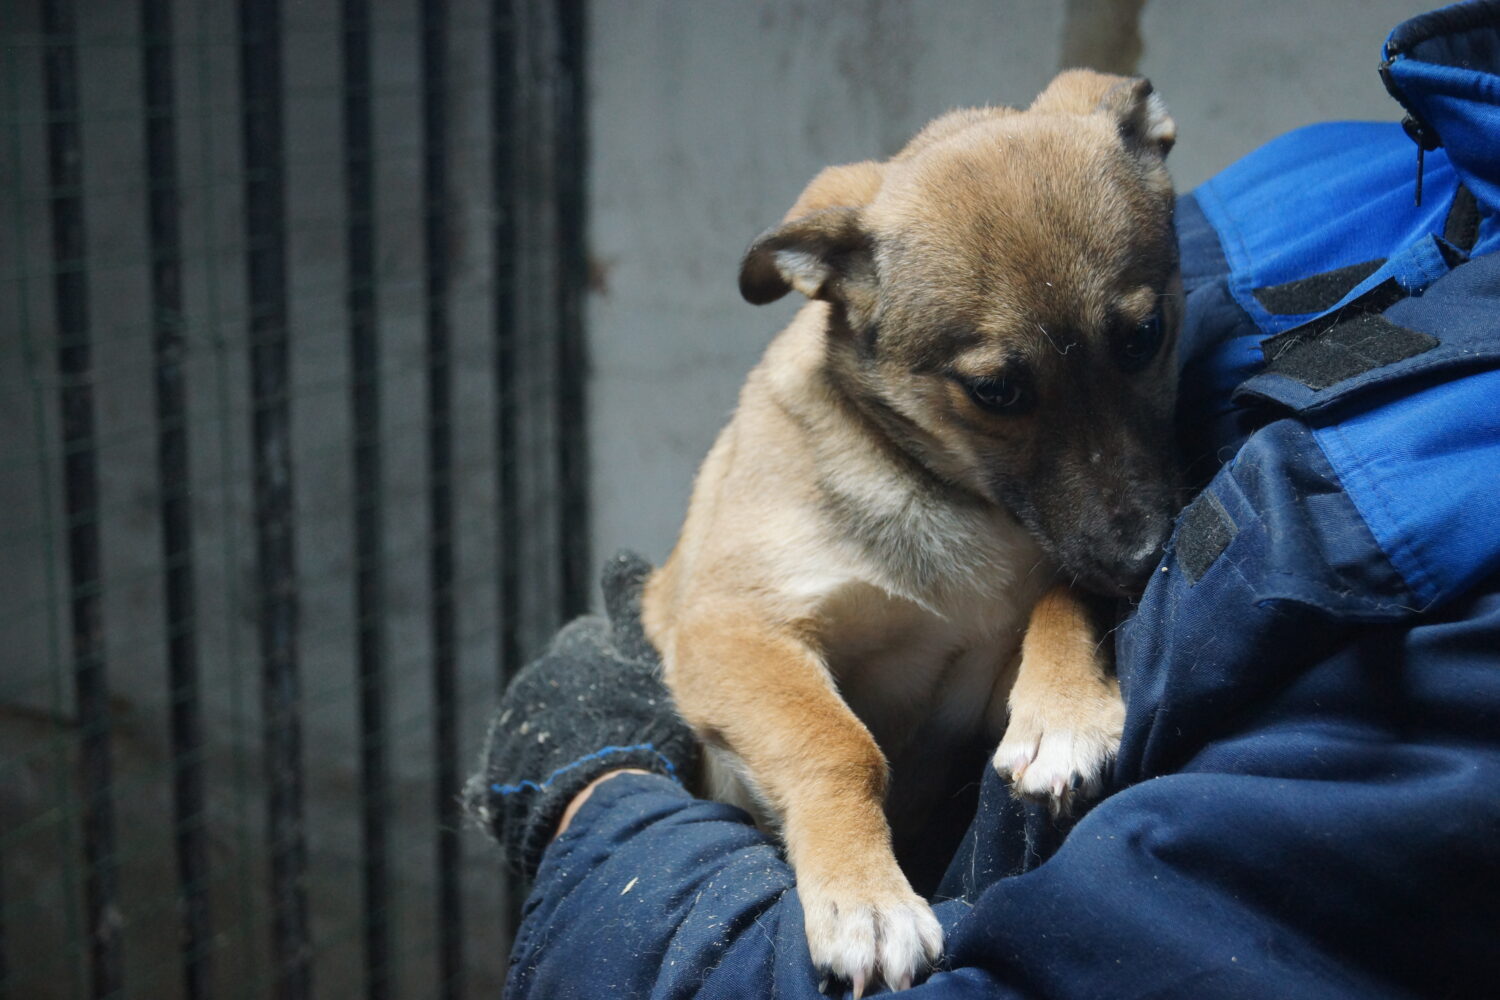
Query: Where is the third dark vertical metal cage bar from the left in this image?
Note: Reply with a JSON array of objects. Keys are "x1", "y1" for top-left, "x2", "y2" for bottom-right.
[{"x1": 239, "y1": 0, "x2": 312, "y2": 1000}]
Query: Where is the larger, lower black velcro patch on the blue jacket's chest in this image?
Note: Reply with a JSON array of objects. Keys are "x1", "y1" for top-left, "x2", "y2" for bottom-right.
[{"x1": 1262, "y1": 313, "x2": 1439, "y2": 390}]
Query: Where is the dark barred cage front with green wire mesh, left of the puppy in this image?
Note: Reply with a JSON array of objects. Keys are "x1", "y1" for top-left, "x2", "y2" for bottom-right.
[{"x1": 0, "y1": 0, "x2": 588, "y2": 1000}]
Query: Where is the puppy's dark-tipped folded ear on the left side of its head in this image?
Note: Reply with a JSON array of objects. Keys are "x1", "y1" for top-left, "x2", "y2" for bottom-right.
[{"x1": 740, "y1": 207, "x2": 876, "y2": 327}]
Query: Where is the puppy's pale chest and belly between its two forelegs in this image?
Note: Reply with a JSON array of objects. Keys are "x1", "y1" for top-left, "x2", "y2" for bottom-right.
[{"x1": 762, "y1": 489, "x2": 1052, "y2": 837}]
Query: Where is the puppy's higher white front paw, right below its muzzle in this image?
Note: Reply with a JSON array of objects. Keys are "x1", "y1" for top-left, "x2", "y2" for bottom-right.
[{"x1": 995, "y1": 682, "x2": 1125, "y2": 816}]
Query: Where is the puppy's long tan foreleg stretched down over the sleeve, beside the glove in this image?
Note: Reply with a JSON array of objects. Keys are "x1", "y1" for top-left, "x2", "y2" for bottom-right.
[{"x1": 668, "y1": 607, "x2": 942, "y2": 994}]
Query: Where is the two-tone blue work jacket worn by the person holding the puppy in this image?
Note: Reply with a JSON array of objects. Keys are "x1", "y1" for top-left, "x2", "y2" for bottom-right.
[{"x1": 506, "y1": 3, "x2": 1500, "y2": 1000}]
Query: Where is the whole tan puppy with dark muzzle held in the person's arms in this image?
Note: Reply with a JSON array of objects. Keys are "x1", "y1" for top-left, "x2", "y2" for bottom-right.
[{"x1": 645, "y1": 70, "x2": 1178, "y2": 996}]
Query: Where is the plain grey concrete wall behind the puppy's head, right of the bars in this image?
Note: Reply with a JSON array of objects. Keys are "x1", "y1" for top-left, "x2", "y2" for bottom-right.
[{"x1": 588, "y1": 0, "x2": 1431, "y2": 569}]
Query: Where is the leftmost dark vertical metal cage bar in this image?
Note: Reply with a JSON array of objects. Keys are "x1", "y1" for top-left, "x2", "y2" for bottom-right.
[{"x1": 42, "y1": 0, "x2": 125, "y2": 997}]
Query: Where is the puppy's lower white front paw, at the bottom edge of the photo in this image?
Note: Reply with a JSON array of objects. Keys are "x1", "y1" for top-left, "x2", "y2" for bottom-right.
[{"x1": 798, "y1": 861, "x2": 942, "y2": 997}]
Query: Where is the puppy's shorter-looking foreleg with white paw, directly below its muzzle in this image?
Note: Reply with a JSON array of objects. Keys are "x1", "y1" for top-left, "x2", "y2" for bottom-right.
[{"x1": 995, "y1": 586, "x2": 1125, "y2": 813}]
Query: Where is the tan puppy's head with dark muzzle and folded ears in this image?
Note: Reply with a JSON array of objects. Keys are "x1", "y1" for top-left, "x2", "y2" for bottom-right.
[{"x1": 740, "y1": 70, "x2": 1181, "y2": 594}]
